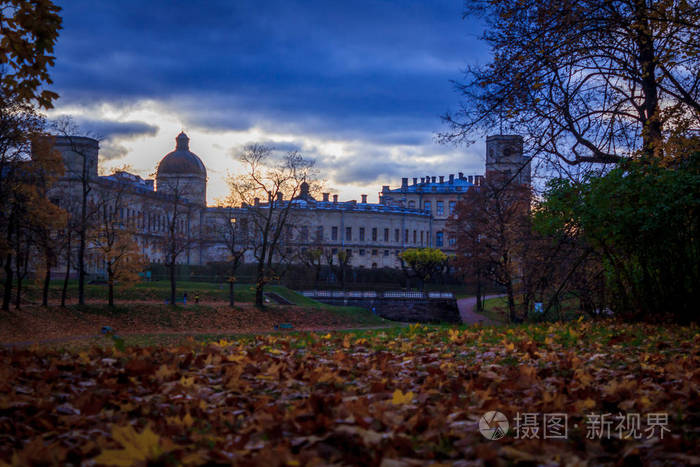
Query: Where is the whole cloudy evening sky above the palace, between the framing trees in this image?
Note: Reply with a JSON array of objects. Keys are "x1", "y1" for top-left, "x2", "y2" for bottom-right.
[{"x1": 48, "y1": 0, "x2": 489, "y2": 204}]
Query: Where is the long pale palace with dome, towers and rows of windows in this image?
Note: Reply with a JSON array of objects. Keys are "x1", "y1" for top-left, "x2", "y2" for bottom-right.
[{"x1": 51, "y1": 133, "x2": 530, "y2": 275}]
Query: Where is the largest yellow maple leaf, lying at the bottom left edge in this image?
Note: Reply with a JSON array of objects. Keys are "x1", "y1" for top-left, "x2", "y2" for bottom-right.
[{"x1": 94, "y1": 425, "x2": 163, "y2": 466}]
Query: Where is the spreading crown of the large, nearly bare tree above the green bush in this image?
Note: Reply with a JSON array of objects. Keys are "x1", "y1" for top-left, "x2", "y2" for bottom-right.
[{"x1": 441, "y1": 0, "x2": 700, "y2": 164}]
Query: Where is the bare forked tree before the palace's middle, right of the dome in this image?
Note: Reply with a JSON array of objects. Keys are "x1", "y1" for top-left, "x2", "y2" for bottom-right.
[{"x1": 229, "y1": 144, "x2": 313, "y2": 307}]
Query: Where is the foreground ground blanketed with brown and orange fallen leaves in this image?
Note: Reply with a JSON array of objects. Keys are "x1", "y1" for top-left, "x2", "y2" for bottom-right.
[{"x1": 0, "y1": 321, "x2": 700, "y2": 466}]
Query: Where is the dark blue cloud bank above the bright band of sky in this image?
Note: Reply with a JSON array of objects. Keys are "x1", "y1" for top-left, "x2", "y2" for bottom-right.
[{"x1": 54, "y1": 0, "x2": 485, "y2": 144}]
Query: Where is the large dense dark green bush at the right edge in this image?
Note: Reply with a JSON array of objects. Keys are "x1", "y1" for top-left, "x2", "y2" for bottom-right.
[{"x1": 538, "y1": 153, "x2": 700, "y2": 322}]
